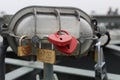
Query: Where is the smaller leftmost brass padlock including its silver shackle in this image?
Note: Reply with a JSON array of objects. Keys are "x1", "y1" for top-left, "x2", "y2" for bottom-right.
[{"x1": 18, "y1": 36, "x2": 32, "y2": 56}]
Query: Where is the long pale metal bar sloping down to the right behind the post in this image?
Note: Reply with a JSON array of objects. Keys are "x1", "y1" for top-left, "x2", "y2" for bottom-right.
[{"x1": 5, "y1": 58, "x2": 120, "y2": 80}]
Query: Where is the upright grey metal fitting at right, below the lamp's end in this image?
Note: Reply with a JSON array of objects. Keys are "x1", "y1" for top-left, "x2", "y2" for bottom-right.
[{"x1": 95, "y1": 41, "x2": 108, "y2": 80}]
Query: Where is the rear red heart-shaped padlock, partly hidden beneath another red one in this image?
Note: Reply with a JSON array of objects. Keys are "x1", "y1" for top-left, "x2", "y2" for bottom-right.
[{"x1": 55, "y1": 36, "x2": 77, "y2": 54}]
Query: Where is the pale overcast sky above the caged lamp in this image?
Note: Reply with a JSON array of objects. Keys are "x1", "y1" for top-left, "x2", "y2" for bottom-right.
[{"x1": 0, "y1": 0, "x2": 120, "y2": 14}]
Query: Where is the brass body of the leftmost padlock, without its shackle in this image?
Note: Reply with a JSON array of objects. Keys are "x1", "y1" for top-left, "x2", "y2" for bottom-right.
[{"x1": 18, "y1": 45, "x2": 32, "y2": 56}]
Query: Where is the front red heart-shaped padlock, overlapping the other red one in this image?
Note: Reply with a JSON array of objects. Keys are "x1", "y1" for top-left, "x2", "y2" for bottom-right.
[{"x1": 48, "y1": 30, "x2": 72, "y2": 46}]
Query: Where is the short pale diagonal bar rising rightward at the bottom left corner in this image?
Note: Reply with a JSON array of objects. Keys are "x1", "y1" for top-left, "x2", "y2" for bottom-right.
[{"x1": 5, "y1": 67, "x2": 34, "y2": 80}]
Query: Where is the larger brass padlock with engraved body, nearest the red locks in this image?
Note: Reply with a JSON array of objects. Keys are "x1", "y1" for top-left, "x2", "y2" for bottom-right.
[{"x1": 37, "y1": 42, "x2": 56, "y2": 64}]
